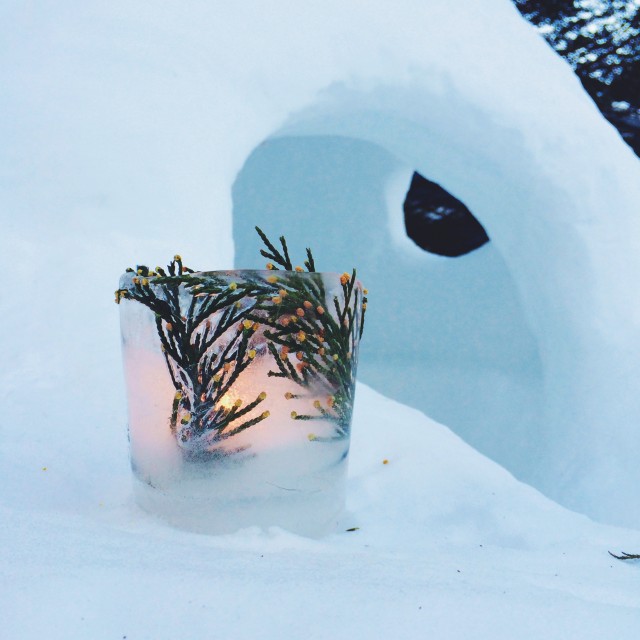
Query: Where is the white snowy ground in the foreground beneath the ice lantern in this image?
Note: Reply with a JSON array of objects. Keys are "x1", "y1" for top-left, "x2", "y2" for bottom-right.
[{"x1": 0, "y1": 386, "x2": 640, "y2": 640}]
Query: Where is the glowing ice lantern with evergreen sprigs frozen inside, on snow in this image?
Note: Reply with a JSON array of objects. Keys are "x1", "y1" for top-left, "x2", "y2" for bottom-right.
[{"x1": 116, "y1": 256, "x2": 366, "y2": 536}]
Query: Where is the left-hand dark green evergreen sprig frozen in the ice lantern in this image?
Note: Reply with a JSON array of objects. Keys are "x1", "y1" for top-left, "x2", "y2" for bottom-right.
[{"x1": 116, "y1": 255, "x2": 269, "y2": 456}]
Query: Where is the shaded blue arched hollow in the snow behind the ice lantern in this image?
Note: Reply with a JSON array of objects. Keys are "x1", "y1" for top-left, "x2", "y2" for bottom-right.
[{"x1": 233, "y1": 135, "x2": 543, "y2": 480}]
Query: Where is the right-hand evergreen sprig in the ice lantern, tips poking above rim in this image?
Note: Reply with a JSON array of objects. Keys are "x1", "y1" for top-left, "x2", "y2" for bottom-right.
[{"x1": 256, "y1": 227, "x2": 367, "y2": 440}]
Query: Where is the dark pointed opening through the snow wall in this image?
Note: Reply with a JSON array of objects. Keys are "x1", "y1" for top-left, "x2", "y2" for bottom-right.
[{"x1": 403, "y1": 173, "x2": 489, "y2": 258}]
